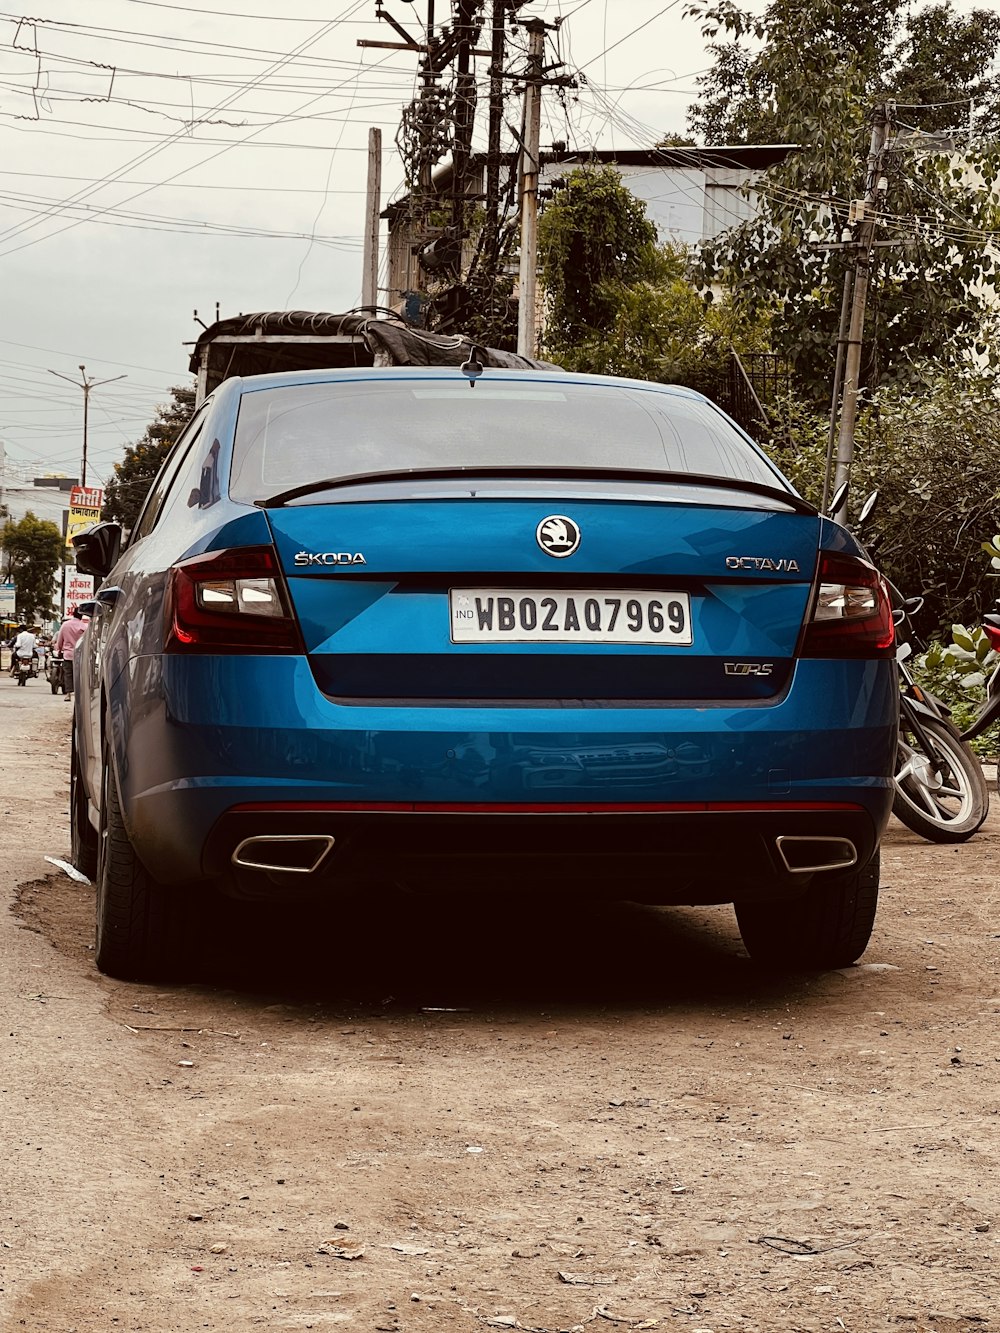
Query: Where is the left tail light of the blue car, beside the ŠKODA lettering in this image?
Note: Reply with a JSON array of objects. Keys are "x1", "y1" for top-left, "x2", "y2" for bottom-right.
[{"x1": 164, "y1": 547, "x2": 303, "y2": 653}]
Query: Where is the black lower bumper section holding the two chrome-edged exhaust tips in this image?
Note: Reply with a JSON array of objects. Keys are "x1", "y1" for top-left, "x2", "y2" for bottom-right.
[{"x1": 205, "y1": 804, "x2": 879, "y2": 904}]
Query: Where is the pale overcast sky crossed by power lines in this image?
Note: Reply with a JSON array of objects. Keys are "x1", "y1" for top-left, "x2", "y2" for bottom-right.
[{"x1": 0, "y1": 0, "x2": 720, "y2": 484}]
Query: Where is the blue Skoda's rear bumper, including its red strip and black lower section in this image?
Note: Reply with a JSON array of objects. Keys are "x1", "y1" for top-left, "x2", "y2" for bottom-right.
[{"x1": 111, "y1": 656, "x2": 897, "y2": 901}]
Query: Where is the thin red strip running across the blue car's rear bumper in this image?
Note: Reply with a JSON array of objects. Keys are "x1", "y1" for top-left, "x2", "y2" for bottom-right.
[{"x1": 229, "y1": 801, "x2": 864, "y2": 814}]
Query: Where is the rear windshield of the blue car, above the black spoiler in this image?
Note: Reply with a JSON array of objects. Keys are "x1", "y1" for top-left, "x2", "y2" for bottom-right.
[{"x1": 229, "y1": 372, "x2": 783, "y2": 501}]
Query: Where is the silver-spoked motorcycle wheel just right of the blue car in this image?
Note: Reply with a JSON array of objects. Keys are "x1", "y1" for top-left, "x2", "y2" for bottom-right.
[{"x1": 892, "y1": 717, "x2": 989, "y2": 842}]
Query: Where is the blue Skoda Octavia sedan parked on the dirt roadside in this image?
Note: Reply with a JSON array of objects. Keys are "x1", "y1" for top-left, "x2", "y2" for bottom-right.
[{"x1": 71, "y1": 364, "x2": 897, "y2": 980}]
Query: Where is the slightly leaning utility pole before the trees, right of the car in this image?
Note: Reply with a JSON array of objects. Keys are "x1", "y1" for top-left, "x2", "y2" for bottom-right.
[{"x1": 831, "y1": 101, "x2": 896, "y2": 523}]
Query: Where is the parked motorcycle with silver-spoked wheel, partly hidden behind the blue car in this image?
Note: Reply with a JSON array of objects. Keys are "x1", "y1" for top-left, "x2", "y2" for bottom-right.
[{"x1": 889, "y1": 585, "x2": 1000, "y2": 842}]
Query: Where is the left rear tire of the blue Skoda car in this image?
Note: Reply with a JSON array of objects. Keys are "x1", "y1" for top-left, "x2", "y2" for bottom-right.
[{"x1": 95, "y1": 753, "x2": 191, "y2": 981}]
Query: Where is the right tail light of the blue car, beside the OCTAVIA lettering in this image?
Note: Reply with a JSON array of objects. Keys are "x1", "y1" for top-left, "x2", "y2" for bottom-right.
[{"x1": 799, "y1": 551, "x2": 896, "y2": 657}]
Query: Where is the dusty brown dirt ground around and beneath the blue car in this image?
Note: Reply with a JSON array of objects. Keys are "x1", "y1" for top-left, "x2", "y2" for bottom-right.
[{"x1": 0, "y1": 666, "x2": 1000, "y2": 1333}]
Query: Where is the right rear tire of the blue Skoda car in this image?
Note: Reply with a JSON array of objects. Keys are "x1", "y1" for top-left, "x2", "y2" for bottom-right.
[{"x1": 736, "y1": 852, "x2": 879, "y2": 972}]
